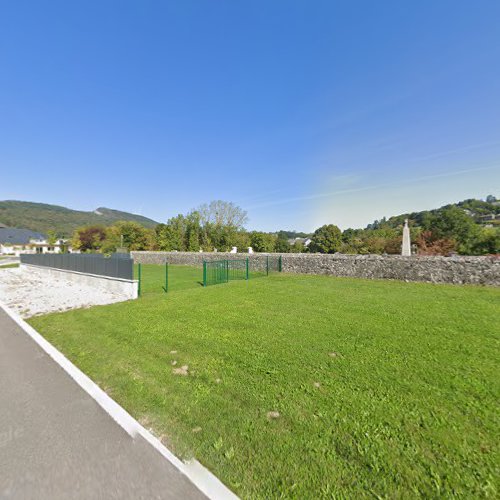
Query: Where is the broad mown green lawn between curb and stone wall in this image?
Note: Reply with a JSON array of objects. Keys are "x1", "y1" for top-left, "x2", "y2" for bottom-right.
[{"x1": 30, "y1": 266, "x2": 500, "y2": 498}]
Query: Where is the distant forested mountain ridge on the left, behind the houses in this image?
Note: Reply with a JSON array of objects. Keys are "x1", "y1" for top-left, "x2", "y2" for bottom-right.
[{"x1": 0, "y1": 200, "x2": 158, "y2": 237}]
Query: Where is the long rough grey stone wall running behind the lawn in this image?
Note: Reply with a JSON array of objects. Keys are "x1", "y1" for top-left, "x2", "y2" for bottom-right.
[{"x1": 131, "y1": 252, "x2": 500, "y2": 286}]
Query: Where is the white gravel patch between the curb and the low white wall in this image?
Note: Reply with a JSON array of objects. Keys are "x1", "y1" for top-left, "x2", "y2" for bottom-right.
[{"x1": 0, "y1": 268, "x2": 129, "y2": 318}]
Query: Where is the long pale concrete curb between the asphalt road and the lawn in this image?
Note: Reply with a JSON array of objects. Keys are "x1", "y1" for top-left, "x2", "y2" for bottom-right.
[{"x1": 0, "y1": 301, "x2": 238, "y2": 500}]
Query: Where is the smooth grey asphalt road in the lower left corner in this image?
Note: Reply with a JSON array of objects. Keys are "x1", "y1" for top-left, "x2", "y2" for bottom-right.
[{"x1": 0, "y1": 308, "x2": 206, "y2": 500}]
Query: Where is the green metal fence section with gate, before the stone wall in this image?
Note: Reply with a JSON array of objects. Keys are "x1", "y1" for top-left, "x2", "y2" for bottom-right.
[{"x1": 203, "y1": 256, "x2": 281, "y2": 286}]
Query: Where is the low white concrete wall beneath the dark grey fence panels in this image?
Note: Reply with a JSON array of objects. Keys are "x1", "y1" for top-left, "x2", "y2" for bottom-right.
[{"x1": 20, "y1": 264, "x2": 139, "y2": 300}]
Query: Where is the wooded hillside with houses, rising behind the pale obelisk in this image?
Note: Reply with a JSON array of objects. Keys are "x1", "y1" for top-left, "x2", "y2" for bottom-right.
[{"x1": 366, "y1": 195, "x2": 500, "y2": 229}]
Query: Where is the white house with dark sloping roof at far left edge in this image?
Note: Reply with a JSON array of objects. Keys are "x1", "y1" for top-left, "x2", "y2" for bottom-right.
[{"x1": 0, "y1": 228, "x2": 71, "y2": 256}]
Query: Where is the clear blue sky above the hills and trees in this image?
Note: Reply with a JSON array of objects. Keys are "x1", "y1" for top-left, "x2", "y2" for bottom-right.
[{"x1": 0, "y1": 0, "x2": 500, "y2": 231}]
